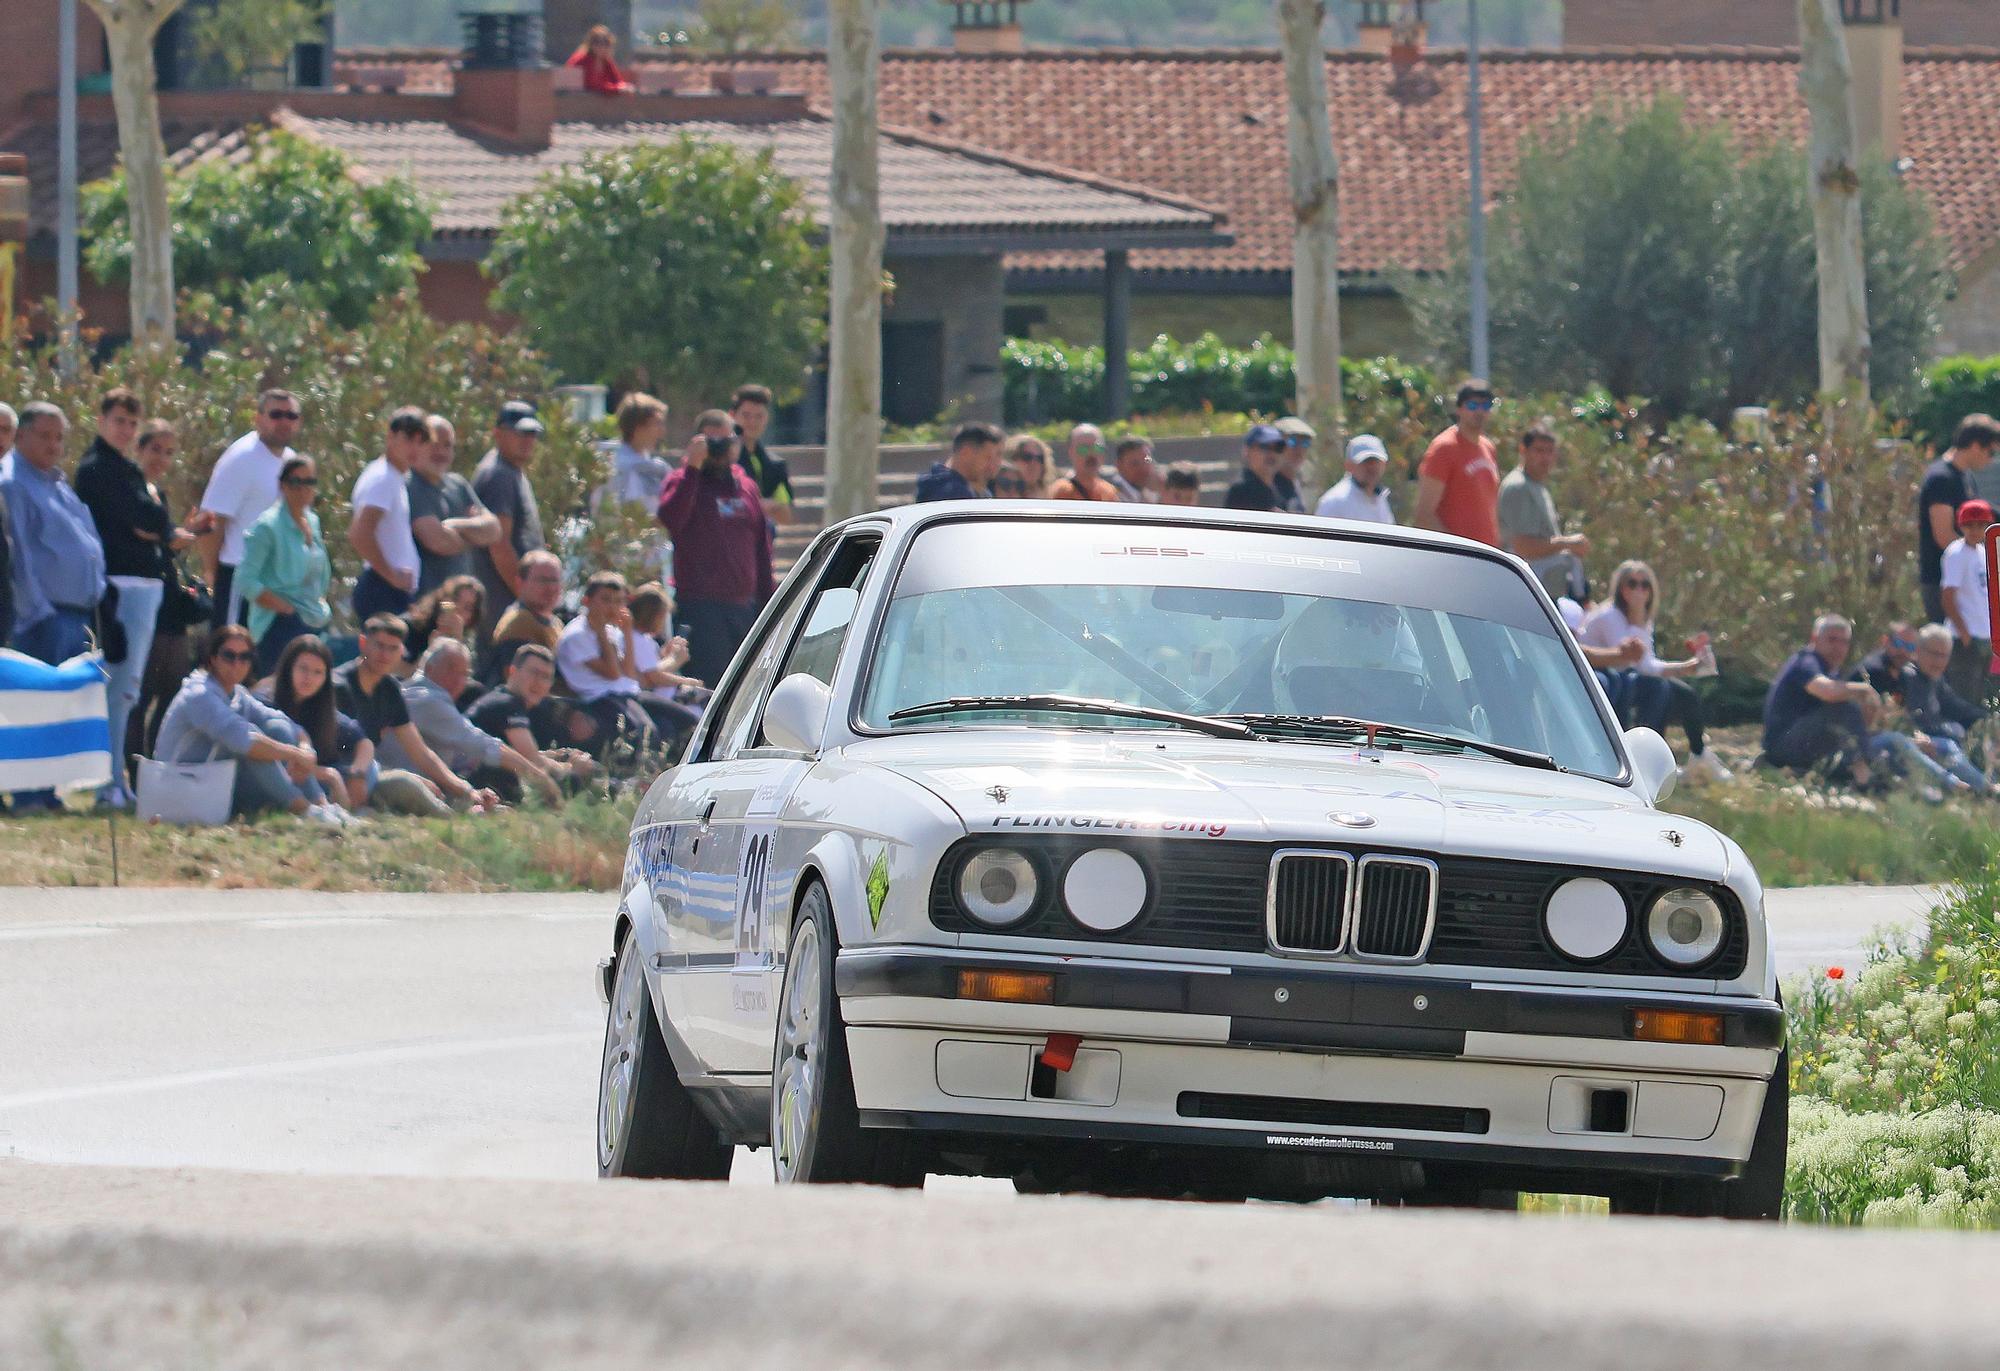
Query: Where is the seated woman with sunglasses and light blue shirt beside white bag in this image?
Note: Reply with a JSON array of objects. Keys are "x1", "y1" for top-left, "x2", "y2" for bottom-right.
[{"x1": 154, "y1": 624, "x2": 354, "y2": 827}]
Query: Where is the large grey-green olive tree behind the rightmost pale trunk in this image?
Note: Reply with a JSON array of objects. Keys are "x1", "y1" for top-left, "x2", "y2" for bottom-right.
[{"x1": 1406, "y1": 96, "x2": 1950, "y2": 416}]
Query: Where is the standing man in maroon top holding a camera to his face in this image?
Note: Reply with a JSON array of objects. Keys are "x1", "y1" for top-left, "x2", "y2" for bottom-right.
[{"x1": 660, "y1": 410, "x2": 778, "y2": 686}]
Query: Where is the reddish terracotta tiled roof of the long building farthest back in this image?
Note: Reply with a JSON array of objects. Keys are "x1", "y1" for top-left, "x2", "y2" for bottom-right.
[{"x1": 608, "y1": 48, "x2": 2000, "y2": 274}]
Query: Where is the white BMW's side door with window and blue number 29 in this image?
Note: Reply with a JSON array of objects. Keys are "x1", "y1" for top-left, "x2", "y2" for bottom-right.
[{"x1": 714, "y1": 532, "x2": 882, "y2": 1071}]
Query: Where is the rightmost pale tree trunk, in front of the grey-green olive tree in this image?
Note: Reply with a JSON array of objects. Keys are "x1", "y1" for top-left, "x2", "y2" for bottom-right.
[{"x1": 1798, "y1": 0, "x2": 1868, "y2": 400}]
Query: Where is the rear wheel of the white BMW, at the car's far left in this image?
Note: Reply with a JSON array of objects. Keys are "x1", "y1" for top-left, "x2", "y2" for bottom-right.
[{"x1": 598, "y1": 929, "x2": 736, "y2": 1181}]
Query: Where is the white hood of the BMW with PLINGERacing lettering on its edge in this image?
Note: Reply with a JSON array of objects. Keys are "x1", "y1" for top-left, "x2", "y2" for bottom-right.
[{"x1": 846, "y1": 729, "x2": 1728, "y2": 881}]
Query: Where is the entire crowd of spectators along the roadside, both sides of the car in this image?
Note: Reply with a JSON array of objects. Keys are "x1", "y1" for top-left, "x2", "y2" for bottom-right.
[{"x1": 11, "y1": 380, "x2": 2000, "y2": 825}]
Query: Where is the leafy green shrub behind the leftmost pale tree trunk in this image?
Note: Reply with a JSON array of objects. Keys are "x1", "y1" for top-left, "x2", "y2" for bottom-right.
[{"x1": 82, "y1": 128, "x2": 430, "y2": 328}]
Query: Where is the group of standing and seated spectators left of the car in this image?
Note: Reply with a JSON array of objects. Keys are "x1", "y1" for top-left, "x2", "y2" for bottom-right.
[{"x1": 0, "y1": 386, "x2": 764, "y2": 827}]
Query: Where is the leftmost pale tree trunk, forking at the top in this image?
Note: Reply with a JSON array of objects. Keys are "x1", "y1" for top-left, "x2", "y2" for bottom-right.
[{"x1": 86, "y1": 0, "x2": 182, "y2": 344}]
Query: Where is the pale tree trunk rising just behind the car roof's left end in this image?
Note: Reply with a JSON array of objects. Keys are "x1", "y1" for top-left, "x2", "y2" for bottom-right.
[{"x1": 826, "y1": 0, "x2": 882, "y2": 524}]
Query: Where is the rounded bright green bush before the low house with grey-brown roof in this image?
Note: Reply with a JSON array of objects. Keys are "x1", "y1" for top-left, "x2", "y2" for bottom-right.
[{"x1": 486, "y1": 138, "x2": 826, "y2": 412}]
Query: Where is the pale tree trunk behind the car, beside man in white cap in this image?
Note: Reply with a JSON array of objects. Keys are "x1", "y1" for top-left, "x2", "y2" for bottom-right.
[{"x1": 1278, "y1": 0, "x2": 1342, "y2": 486}]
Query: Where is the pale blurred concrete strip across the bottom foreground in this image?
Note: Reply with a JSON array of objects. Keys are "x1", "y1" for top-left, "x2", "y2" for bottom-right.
[{"x1": 0, "y1": 1163, "x2": 2000, "y2": 1371}]
